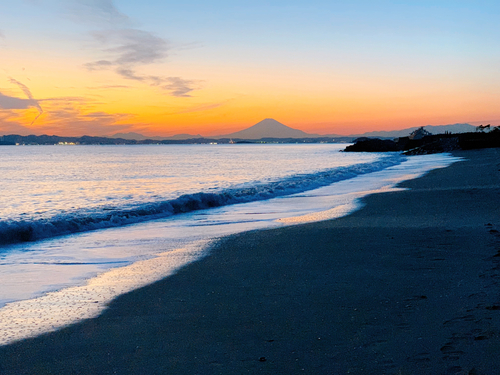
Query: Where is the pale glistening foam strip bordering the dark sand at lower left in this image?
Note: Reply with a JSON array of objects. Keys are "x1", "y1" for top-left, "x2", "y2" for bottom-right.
[{"x1": 0, "y1": 240, "x2": 210, "y2": 345}]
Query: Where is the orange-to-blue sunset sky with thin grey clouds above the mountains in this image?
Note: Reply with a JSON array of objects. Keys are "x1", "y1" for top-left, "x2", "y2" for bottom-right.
[{"x1": 0, "y1": 0, "x2": 500, "y2": 136}]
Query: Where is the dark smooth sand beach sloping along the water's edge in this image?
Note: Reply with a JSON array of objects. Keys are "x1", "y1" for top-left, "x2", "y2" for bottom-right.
[{"x1": 0, "y1": 149, "x2": 500, "y2": 375}]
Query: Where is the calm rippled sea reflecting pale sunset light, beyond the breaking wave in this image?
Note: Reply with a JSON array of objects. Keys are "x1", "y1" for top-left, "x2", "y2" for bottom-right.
[{"x1": 0, "y1": 145, "x2": 380, "y2": 220}]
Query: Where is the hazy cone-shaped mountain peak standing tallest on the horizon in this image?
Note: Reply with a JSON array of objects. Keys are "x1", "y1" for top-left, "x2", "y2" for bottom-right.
[{"x1": 217, "y1": 118, "x2": 321, "y2": 139}]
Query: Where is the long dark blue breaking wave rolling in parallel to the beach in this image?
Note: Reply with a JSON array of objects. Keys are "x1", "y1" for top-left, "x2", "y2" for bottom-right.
[{"x1": 0, "y1": 154, "x2": 406, "y2": 245}]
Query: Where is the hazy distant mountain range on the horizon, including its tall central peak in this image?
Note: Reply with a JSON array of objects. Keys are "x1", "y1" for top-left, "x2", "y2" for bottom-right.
[{"x1": 111, "y1": 118, "x2": 476, "y2": 141}]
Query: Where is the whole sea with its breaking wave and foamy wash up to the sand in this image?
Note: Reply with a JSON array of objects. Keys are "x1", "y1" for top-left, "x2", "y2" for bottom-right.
[{"x1": 0, "y1": 144, "x2": 459, "y2": 344}]
